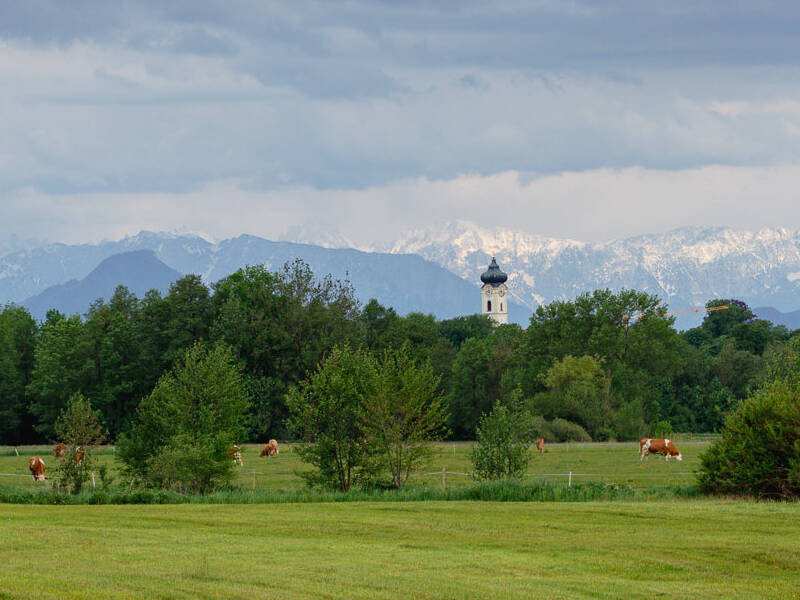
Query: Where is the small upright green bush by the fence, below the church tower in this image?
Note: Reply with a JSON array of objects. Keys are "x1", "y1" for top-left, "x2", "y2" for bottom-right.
[{"x1": 470, "y1": 401, "x2": 531, "y2": 480}]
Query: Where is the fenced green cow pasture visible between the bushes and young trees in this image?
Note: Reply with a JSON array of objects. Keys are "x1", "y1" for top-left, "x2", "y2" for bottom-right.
[{"x1": 0, "y1": 440, "x2": 709, "y2": 491}]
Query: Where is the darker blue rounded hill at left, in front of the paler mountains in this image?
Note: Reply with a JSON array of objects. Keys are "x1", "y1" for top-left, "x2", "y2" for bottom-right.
[{"x1": 22, "y1": 250, "x2": 183, "y2": 319}]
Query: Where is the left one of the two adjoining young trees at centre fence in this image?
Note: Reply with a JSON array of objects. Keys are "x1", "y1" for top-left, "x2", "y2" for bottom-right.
[{"x1": 287, "y1": 345, "x2": 377, "y2": 492}]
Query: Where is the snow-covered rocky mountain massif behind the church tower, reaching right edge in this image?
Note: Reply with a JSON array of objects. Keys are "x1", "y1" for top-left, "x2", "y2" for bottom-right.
[{"x1": 391, "y1": 221, "x2": 800, "y2": 322}]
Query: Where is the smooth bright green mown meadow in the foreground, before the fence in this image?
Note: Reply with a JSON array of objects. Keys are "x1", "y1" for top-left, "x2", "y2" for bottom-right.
[{"x1": 0, "y1": 500, "x2": 800, "y2": 600}]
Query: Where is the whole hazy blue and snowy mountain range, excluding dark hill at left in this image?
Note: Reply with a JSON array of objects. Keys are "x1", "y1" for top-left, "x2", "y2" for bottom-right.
[{"x1": 0, "y1": 221, "x2": 800, "y2": 328}]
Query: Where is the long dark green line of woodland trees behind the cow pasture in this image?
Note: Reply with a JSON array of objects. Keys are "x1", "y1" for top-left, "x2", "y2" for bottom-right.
[{"x1": 0, "y1": 260, "x2": 798, "y2": 446}]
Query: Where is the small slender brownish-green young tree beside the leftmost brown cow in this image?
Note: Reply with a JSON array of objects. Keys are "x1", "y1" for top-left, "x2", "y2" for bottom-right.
[{"x1": 55, "y1": 393, "x2": 106, "y2": 494}]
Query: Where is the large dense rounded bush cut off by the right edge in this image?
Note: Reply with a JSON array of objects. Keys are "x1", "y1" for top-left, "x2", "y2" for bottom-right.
[{"x1": 698, "y1": 380, "x2": 800, "y2": 499}]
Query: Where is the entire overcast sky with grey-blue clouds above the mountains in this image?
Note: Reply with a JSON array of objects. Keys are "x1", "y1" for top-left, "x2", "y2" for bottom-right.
[{"x1": 0, "y1": 0, "x2": 800, "y2": 244}]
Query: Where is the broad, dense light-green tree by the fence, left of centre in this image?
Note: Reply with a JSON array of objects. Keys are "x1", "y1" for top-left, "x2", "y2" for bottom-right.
[{"x1": 117, "y1": 342, "x2": 249, "y2": 494}]
